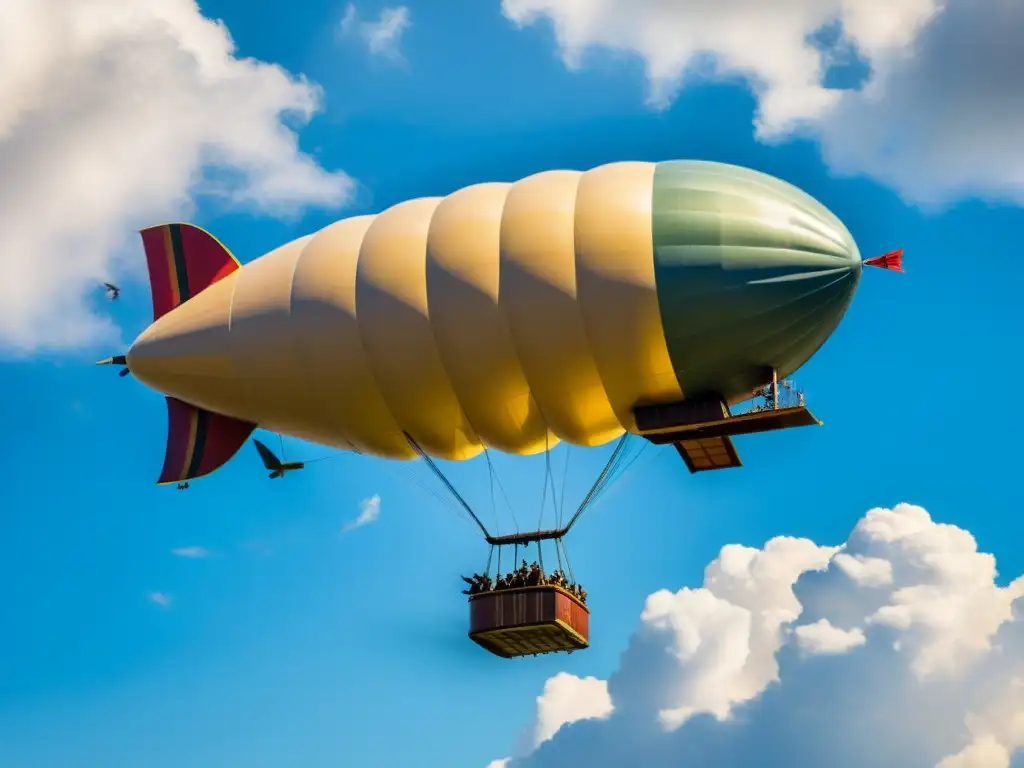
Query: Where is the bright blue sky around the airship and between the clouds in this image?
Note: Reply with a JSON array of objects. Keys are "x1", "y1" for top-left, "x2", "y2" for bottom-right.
[{"x1": 0, "y1": 0, "x2": 1024, "y2": 768}]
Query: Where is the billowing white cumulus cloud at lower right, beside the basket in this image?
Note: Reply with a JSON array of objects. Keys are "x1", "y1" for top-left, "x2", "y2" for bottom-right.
[{"x1": 489, "y1": 504, "x2": 1024, "y2": 768}]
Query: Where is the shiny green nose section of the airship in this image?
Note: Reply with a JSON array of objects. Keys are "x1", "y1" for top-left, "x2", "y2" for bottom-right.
[{"x1": 652, "y1": 161, "x2": 861, "y2": 402}]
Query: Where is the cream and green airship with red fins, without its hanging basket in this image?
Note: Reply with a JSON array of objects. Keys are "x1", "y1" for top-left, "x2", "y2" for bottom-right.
[{"x1": 99, "y1": 161, "x2": 900, "y2": 654}]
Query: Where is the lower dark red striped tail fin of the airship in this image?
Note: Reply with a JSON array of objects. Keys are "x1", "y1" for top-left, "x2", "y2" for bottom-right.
[{"x1": 157, "y1": 397, "x2": 256, "y2": 485}]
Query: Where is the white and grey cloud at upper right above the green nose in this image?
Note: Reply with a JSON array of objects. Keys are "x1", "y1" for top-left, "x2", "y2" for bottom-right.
[{"x1": 502, "y1": 0, "x2": 1024, "y2": 205}]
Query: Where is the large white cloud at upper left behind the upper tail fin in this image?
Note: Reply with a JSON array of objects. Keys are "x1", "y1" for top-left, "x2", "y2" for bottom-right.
[{"x1": 0, "y1": 0, "x2": 353, "y2": 353}]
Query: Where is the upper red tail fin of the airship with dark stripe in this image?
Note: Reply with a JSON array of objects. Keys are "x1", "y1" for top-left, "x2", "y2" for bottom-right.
[{"x1": 140, "y1": 224, "x2": 241, "y2": 321}]
